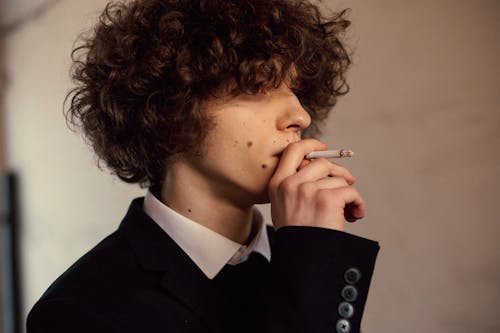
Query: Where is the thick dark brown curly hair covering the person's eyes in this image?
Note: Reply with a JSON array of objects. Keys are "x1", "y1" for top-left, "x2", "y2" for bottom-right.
[{"x1": 65, "y1": 0, "x2": 351, "y2": 187}]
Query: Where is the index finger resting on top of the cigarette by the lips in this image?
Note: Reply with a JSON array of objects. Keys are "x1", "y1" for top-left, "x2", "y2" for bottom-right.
[{"x1": 270, "y1": 139, "x2": 328, "y2": 186}]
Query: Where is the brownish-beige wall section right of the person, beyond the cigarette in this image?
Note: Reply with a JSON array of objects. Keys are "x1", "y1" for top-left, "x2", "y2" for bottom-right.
[{"x1": 328, "y1": 1, "x2": 500, "y2": 333}]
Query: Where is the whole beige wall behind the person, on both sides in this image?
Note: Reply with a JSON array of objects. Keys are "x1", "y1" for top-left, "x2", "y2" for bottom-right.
[{"x1": 0, "y1": 0, "x2": 500, "y2": 333}]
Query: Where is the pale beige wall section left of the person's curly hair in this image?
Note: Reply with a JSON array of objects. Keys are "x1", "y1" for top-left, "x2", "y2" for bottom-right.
[{"x1": 1, "y1": 0, "x2": 142, "y2": 330}]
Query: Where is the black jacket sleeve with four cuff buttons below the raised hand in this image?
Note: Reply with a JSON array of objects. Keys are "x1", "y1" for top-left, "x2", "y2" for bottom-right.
[{"x1": 258, "y1": 226, "x2": 379, "y2": 333}]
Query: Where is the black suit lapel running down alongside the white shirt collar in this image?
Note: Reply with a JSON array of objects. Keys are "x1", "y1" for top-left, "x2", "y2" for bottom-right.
[{"x1": 119, "y1": 198, "x2": 227, "y2": 332}]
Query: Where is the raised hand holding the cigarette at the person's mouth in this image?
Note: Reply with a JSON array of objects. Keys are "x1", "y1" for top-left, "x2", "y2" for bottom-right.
[{"x1": 268, "y1": 139, "x2": 365, "y2": 230}]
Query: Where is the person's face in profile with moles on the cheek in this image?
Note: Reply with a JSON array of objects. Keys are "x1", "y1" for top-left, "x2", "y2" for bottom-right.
[{"x1": 186, "y1": 84, "x2": 311, "y2": 205}]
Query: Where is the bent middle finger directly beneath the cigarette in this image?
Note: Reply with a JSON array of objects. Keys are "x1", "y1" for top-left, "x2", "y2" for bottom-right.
[{"x1": 296, "y1": 158, "x2": 356, "y2": 185}]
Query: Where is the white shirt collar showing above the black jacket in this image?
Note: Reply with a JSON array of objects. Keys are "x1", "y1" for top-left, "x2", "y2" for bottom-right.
[{"x1": 143, "y1": 190, "x2": 271, "y2": 279}]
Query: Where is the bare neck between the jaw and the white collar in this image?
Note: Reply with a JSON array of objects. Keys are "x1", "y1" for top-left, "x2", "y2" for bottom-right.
[{"x1": 160, "y1": 161, "x2": 253, "y2": 244}]
